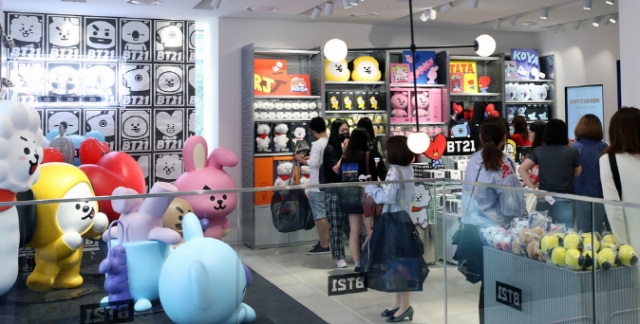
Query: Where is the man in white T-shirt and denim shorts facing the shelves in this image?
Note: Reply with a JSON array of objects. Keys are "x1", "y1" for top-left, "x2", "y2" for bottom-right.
[{"x1": 295, "y1": 117, "x2": 330, "y2": 255}]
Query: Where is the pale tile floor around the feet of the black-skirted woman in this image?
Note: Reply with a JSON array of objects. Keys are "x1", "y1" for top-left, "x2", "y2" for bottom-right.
[{"x1": 237, "y1": 245, "x2": 480, "y2": 324}]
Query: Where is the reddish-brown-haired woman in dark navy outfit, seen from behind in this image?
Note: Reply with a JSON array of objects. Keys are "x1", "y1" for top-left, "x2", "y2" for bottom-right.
[{"x1": 573, "y1": 114, "x2": 609, "y2": 233}]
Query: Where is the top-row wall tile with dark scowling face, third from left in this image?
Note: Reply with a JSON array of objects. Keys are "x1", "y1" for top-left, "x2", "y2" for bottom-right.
[{"x1": 84, "y1": 17, "x2": 118, "y2": 59}]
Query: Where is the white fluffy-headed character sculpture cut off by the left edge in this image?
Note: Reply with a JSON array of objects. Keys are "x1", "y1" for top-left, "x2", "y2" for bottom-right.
[{"x1": 0, "y1": 101, "x2": 43, "y2": 295}]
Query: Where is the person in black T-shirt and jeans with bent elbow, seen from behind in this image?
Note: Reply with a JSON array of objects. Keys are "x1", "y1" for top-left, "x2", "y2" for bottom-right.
[{"x1": 518, "y1": 119, "x2": 582, "y2": 228}]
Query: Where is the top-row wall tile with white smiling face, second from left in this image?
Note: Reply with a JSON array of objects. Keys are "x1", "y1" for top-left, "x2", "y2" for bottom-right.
[{"x1": 47, "y1": 15, "x2": 83, "y2": 58}]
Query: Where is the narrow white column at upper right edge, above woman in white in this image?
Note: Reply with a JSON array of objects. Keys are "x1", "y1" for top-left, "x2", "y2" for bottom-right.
[{"x1": 618, "y1": 0, "x2": 640, "y2": 108}]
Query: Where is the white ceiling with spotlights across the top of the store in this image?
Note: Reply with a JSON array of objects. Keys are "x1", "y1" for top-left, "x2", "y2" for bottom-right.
[{"x1": 3, "y1": 0, "x2": 616, "y2": 32}]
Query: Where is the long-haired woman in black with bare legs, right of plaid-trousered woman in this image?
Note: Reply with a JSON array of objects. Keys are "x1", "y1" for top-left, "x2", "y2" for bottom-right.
[{"x1": 341, "y1": 128, "x2": 378, "y2": 272}]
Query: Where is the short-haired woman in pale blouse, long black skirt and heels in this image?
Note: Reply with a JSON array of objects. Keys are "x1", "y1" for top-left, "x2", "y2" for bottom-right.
[{"x1": 365, "y1": 136, "x2": 414, "y2": 322}]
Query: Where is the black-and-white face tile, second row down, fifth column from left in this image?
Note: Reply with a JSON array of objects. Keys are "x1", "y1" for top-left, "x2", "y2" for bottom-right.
[{"x1": 154, "y1": 64, "x2": 185, "y2": 107}]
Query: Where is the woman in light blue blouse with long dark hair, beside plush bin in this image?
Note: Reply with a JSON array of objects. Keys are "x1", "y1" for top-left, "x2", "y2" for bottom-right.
[{"x1": 453, "y1": 118, "x2": 525, "y2": 323}]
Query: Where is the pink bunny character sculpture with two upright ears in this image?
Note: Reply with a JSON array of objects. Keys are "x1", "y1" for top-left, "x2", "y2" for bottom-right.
[{"x1": 174, "y1": 136, "x2": 238, "y2": 239}]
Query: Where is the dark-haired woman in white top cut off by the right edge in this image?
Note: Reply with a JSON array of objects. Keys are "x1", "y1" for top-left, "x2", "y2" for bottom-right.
[{"x1": 600, "y1": 107, "x2": 640, "y2": 250}]
